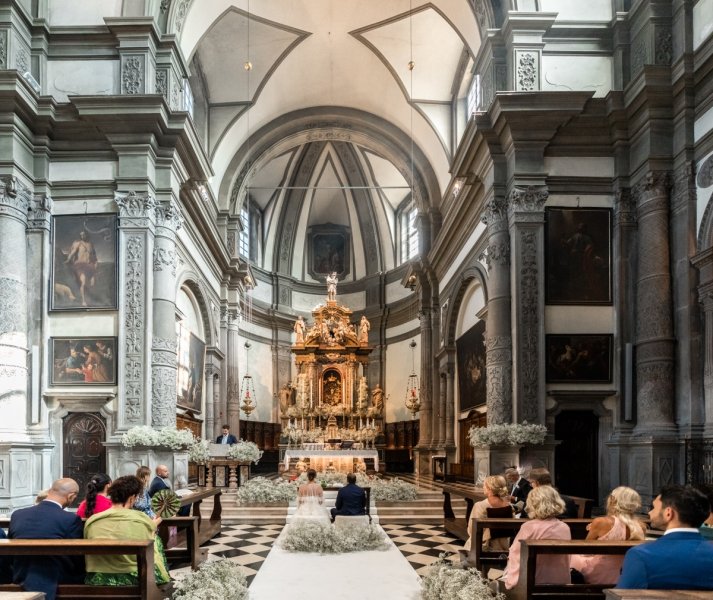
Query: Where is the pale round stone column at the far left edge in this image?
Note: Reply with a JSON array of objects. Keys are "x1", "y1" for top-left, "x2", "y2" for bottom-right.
[{"x1": 0, "y1": 176, "x2": 31, "y2": 438}]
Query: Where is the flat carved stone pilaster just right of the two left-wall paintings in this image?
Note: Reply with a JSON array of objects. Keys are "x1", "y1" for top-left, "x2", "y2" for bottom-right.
[{"x1": 114, "y1": 192, "x2": 156, "y2": 431}]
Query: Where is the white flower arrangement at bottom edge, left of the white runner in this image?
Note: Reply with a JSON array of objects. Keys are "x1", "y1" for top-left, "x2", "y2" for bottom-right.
[{"x1": 172, "y1": 558, "x2": 248, "y2": 600}]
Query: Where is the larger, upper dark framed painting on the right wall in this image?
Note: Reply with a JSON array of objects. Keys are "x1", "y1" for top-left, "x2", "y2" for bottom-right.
[{"x1": 545, "y1": 208, "x2": 612, "y2": 304}]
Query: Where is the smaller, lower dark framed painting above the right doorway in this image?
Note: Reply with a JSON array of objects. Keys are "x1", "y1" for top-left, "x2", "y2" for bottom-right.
[{"x1": 545, "y1": 334, "x2": 612, "y2": 383}]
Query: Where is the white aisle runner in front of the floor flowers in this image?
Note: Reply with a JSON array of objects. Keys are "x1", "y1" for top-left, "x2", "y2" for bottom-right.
[{"x1": 250, "y1": 530, "x2": 421, "y2": 600}]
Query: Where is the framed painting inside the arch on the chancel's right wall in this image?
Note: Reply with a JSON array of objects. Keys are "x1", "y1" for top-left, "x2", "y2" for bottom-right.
[{"x1": 456, "y1": 321, "x2": 487, "y2": 411}]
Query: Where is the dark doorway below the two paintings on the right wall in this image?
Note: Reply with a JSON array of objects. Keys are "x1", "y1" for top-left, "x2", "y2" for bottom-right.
[{"x1": 554, "y1": 410, "x2": 599, "y2": 504}]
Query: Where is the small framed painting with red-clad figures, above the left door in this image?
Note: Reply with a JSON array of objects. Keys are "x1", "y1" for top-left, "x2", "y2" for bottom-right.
[{"x1": 50, "y1": 337, "x2": 116, "y2": 385}]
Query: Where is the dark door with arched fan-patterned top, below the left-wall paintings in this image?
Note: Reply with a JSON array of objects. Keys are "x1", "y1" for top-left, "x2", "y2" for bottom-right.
[{"x1": 62, "y1": 413, "x2": 106, "y2": 505}]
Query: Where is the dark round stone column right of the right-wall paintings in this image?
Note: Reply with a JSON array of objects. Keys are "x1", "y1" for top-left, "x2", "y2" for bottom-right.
[{"x1": 634, "y1": 171, "x2": 676, "y2": 435}]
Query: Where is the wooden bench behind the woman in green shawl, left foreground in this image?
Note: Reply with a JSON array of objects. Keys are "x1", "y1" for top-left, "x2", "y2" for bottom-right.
[{"x1": 0, "y1": 540, "x2": 169, "y2": 600}]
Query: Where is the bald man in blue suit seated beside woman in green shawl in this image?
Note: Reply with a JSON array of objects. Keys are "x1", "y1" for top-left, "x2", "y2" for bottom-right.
[{"x1": 8, "y1": 478, "x2": 84, "y2": 600}]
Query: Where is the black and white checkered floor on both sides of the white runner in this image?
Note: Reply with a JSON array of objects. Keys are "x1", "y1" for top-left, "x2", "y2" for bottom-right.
[{"x1": 171, "y1": 524, "x2": 463, "y2": 584}]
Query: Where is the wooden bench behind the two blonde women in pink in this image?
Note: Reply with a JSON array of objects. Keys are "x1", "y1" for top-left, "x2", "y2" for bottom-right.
[{"x1": 506, "y1": 540, "x2": 644, "y2": 600}]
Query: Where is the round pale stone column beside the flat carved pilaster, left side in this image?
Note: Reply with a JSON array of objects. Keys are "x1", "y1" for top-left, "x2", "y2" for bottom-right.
[{"x1": 151, "y1": 200, "x2": 183, "y2": 428}]
